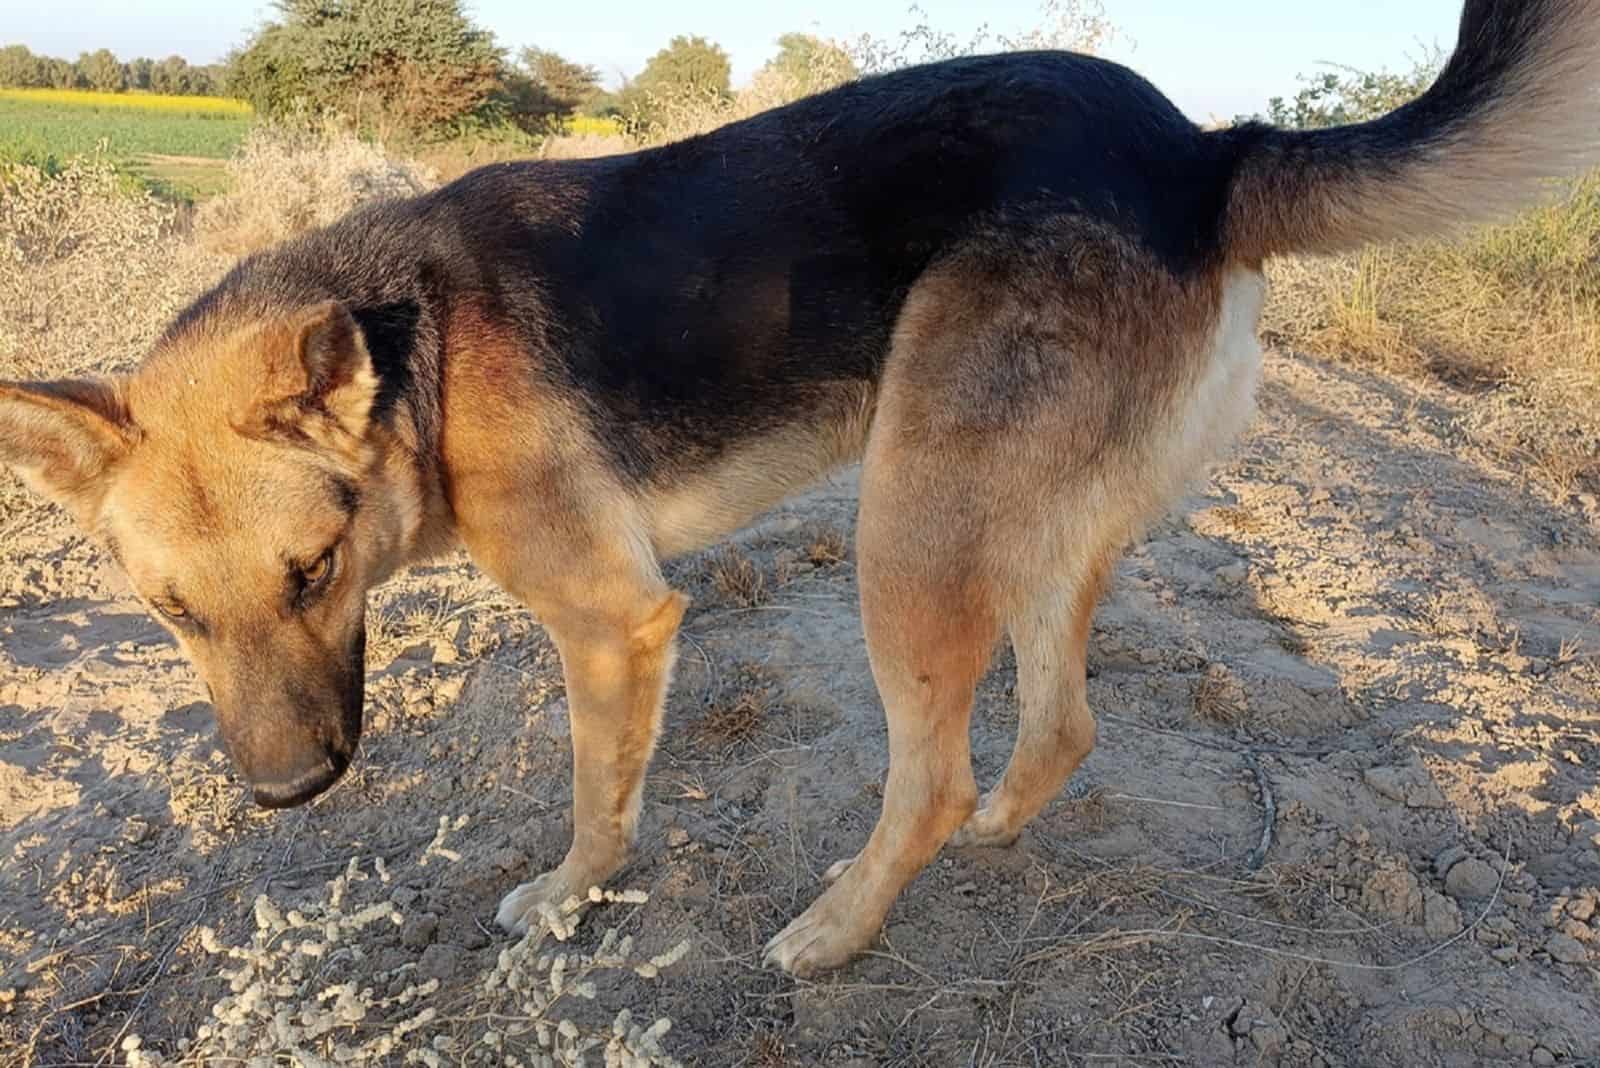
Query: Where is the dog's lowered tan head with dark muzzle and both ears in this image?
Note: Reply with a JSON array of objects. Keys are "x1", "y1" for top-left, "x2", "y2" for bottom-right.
[{"x1": 0, "y1": 304, "x2": 421, "y2": 807}]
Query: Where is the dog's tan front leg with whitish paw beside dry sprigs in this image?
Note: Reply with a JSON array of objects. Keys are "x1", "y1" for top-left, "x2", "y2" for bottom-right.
[{"x1": 496, "y1": 593, "x2": 688, "y2": 932}]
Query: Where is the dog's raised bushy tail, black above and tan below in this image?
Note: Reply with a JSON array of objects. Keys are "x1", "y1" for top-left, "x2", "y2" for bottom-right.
[{"x1": 1213, "y1": 0, "x2": 1600, "y2": 261}]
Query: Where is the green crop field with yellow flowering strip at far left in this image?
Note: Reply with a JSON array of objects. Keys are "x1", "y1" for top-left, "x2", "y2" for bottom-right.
[{"x1": 0, "y1": 90, "x2": 254, "y2": 200}]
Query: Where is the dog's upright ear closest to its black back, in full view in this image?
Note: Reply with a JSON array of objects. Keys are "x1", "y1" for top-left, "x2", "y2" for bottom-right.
[{"x1": 251, "y1": 301, "x2": 378, "y2": 444}]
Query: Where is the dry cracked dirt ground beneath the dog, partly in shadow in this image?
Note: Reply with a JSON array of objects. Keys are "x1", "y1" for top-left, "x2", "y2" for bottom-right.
[{"x1": 0, "y1": 343, "x2": 1600, "y2": 1068}]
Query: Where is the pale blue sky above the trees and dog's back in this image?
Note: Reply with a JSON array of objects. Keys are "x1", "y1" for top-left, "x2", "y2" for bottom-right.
[{"x1": 0, "y1": 0, "x2": 1461, "y2": 122}]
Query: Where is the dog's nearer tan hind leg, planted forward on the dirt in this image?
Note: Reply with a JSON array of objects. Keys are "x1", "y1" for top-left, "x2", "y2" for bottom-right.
[{"x1": 766, "y1": 388, "x2": 998, "y2": 975}]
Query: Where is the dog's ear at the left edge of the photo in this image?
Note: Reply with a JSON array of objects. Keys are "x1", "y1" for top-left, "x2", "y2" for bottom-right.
[{"x1": 0, "y1": 379, "x2": 138, "y2": 528}]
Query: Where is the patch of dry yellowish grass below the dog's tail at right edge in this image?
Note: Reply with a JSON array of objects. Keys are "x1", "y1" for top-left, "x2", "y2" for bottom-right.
[{"x1": 1262, "y1": 174, "x2": 1600, "y2": 496}]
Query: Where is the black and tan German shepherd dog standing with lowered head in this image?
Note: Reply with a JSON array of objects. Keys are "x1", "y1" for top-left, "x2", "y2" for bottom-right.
[{"x1": 0, "y1": 0, "x2": 1600, "y2": 975}]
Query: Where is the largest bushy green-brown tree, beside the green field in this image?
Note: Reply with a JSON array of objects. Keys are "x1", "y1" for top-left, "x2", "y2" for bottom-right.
[{"x1": 227, "y1": 0, "x2": 504, "y2": 134}]
